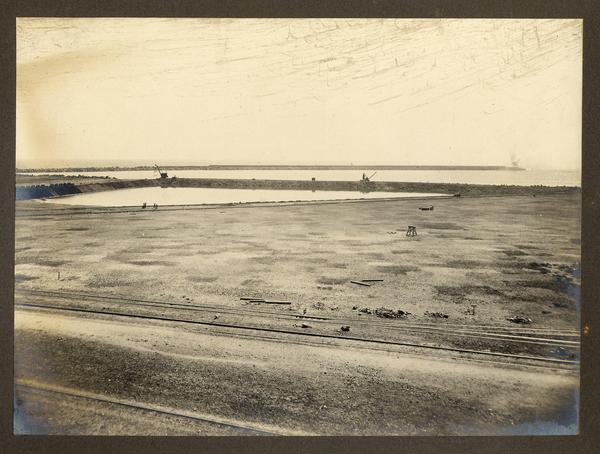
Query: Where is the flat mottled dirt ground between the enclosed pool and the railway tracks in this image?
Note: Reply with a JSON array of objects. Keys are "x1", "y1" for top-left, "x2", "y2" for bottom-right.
[{"x1": 15, "y1": 194, "x2": 580, "y2": 328}]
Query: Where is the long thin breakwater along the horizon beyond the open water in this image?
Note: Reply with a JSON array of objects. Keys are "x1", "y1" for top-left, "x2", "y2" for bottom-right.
[{"x1": 16, "y1": 165, "x2": 525, "y2": 173}]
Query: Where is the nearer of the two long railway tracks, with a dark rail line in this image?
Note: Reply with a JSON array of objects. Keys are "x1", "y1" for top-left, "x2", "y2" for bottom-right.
[{"x1": 15, "y1": 294, "x2": 579, "y2": 367}]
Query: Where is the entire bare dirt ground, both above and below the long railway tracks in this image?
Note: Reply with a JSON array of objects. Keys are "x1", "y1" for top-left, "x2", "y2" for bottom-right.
[{"x1": 15, "y1": 194, "x2": 581, "y2": 434}]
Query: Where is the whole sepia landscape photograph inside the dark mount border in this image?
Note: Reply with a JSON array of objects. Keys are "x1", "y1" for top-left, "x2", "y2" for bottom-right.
[{"x1": 11, "y1": 17, "x2": 589, "y2": 436}]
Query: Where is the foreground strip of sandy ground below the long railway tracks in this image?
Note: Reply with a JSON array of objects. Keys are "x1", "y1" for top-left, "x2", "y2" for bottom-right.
[{"x1": 16, "y1": 311, "x2": 577, "y2": 435}]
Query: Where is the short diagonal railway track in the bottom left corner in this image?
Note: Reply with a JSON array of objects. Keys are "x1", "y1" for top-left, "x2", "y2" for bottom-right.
[{"x1": 15, "y1": 380, "x2": 292, "y2": 435}]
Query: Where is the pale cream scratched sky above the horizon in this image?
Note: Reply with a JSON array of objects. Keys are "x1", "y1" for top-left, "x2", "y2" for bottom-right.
[{"x1": 16, "y1": 18, "x2": 582, "y2": 169}]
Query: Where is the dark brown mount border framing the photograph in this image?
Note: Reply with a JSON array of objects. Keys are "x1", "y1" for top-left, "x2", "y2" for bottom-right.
[{"x1": 0, "y1": 0, "x2": 600, "y2": 454}]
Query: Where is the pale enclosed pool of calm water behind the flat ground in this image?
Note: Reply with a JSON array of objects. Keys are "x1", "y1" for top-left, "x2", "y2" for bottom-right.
[{"x1": 43, "y1": 187, "x2": 448, "y2": 207}]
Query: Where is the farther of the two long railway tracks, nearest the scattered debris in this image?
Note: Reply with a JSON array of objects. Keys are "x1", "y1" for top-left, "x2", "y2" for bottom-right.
[{"x1": 17, "y1": 289, "x2": 579, "y2": 349}]
